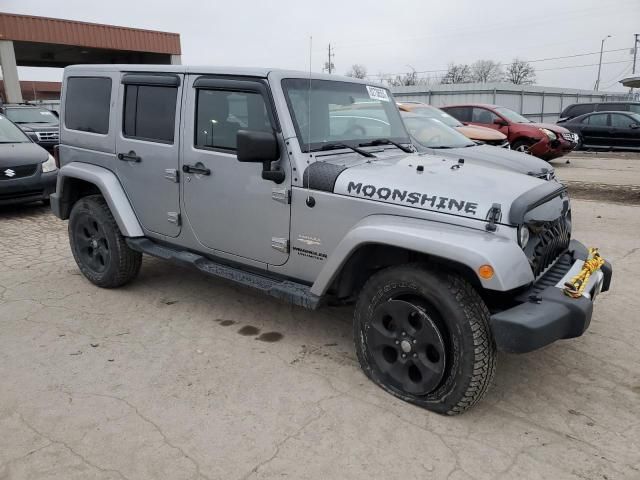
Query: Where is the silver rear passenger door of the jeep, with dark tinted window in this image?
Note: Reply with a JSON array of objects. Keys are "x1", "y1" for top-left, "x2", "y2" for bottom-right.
[{"x1": 116, "y1": 73, "x2": 183, "y2": 237}]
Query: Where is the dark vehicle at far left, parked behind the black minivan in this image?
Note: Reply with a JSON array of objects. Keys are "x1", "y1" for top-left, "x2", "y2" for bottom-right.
[{"x1": 0, "y1": 104, "x2": 60, "y2": 151}]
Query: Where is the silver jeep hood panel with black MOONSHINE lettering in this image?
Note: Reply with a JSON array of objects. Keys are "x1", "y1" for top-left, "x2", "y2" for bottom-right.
[{"x1": 329, "y1": 154, "x2": 561, "y2": 226}]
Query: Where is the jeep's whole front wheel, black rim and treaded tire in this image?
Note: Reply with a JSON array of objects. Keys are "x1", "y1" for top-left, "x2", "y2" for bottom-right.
[{"x1": 354, "y1": 264, "x2": 496, "y2": 415}]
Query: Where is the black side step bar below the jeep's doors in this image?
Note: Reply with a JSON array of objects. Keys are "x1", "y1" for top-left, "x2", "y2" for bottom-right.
[{"x1": 127, "y1": 238, "x2": 321, "y2": 310}]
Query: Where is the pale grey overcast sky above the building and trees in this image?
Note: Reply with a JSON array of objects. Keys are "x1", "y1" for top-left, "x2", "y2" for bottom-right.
[{"x1": 0, "y1": 0, "x2": 640, "y2": 91}]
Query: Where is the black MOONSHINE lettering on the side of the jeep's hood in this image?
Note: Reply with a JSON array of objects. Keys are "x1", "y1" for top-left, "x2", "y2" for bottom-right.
[{"x1": 347, "y1": 182, "x2": 478, "y2": 215}]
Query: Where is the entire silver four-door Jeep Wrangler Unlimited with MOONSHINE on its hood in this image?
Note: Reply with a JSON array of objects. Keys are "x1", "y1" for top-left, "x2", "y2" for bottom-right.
[{"x1": 51, "y1": 65, "x2": 611, "y2": 414}]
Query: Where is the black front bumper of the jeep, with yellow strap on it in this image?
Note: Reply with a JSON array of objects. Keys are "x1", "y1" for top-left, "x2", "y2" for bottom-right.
[{"x1": 490, "y1": 240, "x2": 612, "y2": 353}]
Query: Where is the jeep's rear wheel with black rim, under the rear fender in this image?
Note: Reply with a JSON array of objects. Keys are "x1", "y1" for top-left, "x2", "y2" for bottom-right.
[{"x1": 68, "y1": 195, "x2": 142, "y2": 288}]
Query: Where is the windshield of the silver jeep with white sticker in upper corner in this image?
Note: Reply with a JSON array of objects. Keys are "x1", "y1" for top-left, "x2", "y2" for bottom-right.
[{"x1": 282, "y1": 78, "x2": 411, "y2": 152}]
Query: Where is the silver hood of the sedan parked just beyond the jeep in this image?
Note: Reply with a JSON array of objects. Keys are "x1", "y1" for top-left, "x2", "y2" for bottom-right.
[{"x1": 423, "y1": 145, "x2": 554, "y2": 176}]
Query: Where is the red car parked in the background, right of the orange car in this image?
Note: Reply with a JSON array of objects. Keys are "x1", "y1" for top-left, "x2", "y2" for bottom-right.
[{"x1": 440, "y1": 103, "x2": 578, "y2": 161}]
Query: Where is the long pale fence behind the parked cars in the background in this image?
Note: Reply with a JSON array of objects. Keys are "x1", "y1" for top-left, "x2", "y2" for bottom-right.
[{"x1": 391, "y1": 83, "x2": 633, "y2": 123}]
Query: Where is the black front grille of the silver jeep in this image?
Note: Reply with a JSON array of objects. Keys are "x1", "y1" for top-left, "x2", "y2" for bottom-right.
[{"x1": 527, "y1": 216, "x2": 571, "y2": 278}]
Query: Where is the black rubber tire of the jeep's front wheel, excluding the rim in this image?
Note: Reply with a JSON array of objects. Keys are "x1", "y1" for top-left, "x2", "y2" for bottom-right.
[{"x1": 353, "y1": 264, "x2": 496, "y2": 415}]
